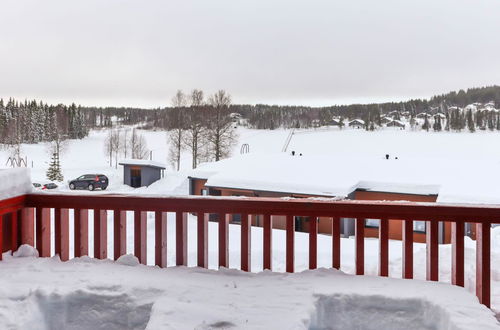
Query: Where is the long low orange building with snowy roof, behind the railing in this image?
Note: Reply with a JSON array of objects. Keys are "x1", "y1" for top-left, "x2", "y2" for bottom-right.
[{"x1": 189, "y1": 154, "x2": 451, "y2": 243}]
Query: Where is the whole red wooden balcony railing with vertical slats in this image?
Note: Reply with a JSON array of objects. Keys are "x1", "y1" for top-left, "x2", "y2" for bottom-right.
[{"x1": 0, "y1": 194, "x2": 500, "y2": 307}]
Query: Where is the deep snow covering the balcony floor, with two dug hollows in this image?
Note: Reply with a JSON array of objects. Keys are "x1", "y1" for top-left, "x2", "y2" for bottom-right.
[{"x1": 0, "y1": 258, "x2": 499, "y2": 330}]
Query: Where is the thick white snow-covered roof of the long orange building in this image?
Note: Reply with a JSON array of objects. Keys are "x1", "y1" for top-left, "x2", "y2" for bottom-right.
[{"x1": 190, "y1": 154, "x2": 448, "y2": 197}]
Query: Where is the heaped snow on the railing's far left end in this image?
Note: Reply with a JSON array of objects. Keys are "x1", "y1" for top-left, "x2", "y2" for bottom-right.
[{"x1": 0, "y1": 168, "x2": 33, "y2": 200}]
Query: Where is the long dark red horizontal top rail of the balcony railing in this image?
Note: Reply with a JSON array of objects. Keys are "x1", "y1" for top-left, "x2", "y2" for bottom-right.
[{"x1": 25, "y1": 193, "x2": 500, "y2": 223}]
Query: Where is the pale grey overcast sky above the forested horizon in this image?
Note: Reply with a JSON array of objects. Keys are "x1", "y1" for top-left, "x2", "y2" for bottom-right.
[{"x1": 0, "y1": 0, "x2": 500, "y2": 107}]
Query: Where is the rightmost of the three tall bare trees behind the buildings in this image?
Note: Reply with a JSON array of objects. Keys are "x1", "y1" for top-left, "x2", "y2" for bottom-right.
[{"x1": 205, "y1": 90, "x2": 236, "y2": 161}]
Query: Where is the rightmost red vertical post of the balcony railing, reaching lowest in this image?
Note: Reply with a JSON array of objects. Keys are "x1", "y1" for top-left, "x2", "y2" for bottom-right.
[{"x1": 476, "y1": 222, "x2": 491, "y2": 308}]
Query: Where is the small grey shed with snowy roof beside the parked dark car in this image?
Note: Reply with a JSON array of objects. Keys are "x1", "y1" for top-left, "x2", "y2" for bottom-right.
[{"x1": 119, "y1": 159, "x2": 166, "y2": 188}]
